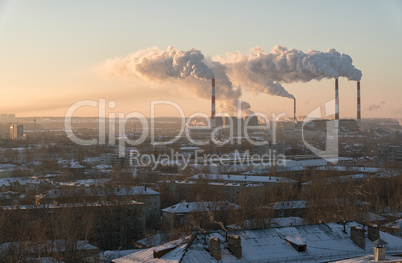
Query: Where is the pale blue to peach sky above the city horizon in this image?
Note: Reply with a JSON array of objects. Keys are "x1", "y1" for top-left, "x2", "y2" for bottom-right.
[{"x1": 0, "y1": 0, "x2": 402, "y2": 120}]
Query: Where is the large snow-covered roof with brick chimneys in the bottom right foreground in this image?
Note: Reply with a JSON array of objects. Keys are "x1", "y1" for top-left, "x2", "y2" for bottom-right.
[{"x1": 112, "y1": 222, "x2": 402, "y2": 263}]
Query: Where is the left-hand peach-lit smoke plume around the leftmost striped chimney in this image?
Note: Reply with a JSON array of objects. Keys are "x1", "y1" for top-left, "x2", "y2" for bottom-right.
[{"x1": 103, "y1": 46, "x2": 250, "y2": 112}]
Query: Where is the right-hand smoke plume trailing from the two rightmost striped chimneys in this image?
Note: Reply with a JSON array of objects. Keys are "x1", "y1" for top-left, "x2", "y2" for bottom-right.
[{"x1": 216, "y1": 46, "x2": 362, "y2": 98}]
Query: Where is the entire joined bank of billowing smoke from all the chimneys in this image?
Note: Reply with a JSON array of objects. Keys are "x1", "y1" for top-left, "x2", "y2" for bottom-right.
[{"x1": 99, "y1": 45, "x2": 362, "y2": 113}]
